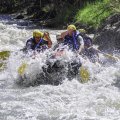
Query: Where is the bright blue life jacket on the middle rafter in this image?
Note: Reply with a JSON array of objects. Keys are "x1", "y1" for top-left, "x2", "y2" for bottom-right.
[{"x1": 64, "y1": 32, "x2": 80, "y2": 51}]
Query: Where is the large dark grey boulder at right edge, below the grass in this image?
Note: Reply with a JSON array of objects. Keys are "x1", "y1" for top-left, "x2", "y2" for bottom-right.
[{"x1": 94, "y1": 14, "x2": 120, "y2": 51}]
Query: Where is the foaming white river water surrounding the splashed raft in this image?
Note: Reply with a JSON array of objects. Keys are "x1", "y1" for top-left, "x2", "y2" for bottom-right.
[{"x1": 0, "y1": 16, "x2": 120, "y2": 120}]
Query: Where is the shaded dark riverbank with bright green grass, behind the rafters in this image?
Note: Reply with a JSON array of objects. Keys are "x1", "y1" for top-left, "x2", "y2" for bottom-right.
[{"x1": 0, "y1": 0, "x2": 116, "y2": 33}]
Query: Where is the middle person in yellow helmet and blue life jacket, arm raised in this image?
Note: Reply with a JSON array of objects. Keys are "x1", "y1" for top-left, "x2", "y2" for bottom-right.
[{"x1": 56, "y1": 25, "x2": 84, "y2": 53}]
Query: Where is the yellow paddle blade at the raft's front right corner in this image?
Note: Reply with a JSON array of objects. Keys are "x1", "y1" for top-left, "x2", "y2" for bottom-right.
[{"x1": 80, "y1": 67, "x2": 90, "y2": 83}]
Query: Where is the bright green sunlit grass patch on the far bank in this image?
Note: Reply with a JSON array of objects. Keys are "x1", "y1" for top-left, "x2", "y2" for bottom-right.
[{"x1": 74, "y1": 0, "x2": 113, "y2": 29}]
